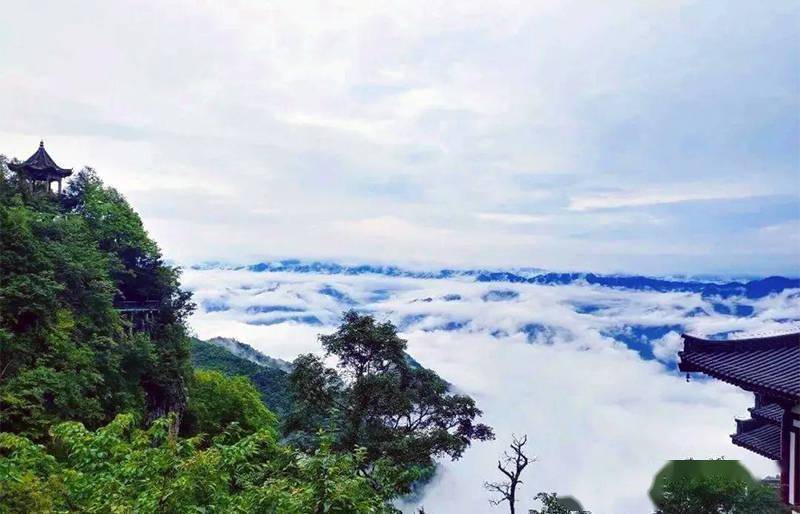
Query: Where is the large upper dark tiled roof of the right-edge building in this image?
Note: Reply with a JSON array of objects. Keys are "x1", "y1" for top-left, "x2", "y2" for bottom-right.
[{"x1": 678, "y1": 333, "x2": 800, "y2": 402}]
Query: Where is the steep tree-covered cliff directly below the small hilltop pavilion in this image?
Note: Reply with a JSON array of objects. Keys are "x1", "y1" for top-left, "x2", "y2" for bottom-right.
[{"x1": 0, "y1": 162, "x2": 192, "y2": 441}]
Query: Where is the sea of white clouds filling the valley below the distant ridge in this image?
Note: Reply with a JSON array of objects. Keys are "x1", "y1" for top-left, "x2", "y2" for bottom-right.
[{"x1": 183, "y1": 267, "x2": 800, "y2": 514}]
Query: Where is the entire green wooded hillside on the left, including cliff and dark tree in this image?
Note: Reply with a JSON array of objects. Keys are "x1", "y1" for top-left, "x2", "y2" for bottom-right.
[{"x1": 0, "y1": 157, "x2": 492, "y2": 513}]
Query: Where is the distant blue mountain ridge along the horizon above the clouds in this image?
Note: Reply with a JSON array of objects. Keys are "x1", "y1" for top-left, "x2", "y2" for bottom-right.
[{"x1": 192, "y1": 259, "x2": 800, "y2": 299}]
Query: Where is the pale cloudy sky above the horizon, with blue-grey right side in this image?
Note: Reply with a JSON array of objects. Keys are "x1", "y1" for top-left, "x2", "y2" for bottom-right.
[{"x1": 0, "y1": 0, "x2": 800, "y2": 275}]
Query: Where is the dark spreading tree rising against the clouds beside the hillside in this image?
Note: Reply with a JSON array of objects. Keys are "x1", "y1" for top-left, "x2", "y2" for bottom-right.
[{"x1": 285, "y1": 311, "x2": 493, "y2": 485}]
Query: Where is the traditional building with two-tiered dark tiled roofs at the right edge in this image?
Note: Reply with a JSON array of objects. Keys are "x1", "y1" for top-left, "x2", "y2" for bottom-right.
[{"x1": 678, "y1": 333, "x2": 800, "y2": 507}]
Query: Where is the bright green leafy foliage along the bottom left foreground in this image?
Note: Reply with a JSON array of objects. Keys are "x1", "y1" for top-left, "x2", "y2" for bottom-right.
[{"x1": 0, "y1": 415, "x2": 392, "y2": 514}]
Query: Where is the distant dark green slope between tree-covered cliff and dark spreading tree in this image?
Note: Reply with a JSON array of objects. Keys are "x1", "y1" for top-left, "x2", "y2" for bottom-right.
[{"x1": 191, "y1": 339, "x2": 292, "y2": 416}]
